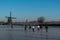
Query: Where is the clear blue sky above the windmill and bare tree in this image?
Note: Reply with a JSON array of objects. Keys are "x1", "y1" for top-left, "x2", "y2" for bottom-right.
[{"x1": 0, "y1": 0, "x2": 60, "y2": 21}]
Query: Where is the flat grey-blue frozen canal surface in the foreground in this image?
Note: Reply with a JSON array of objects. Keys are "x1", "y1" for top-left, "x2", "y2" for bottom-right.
[{"x1": 0, "y1": 25, "x2": 60, "y2": 40}]
